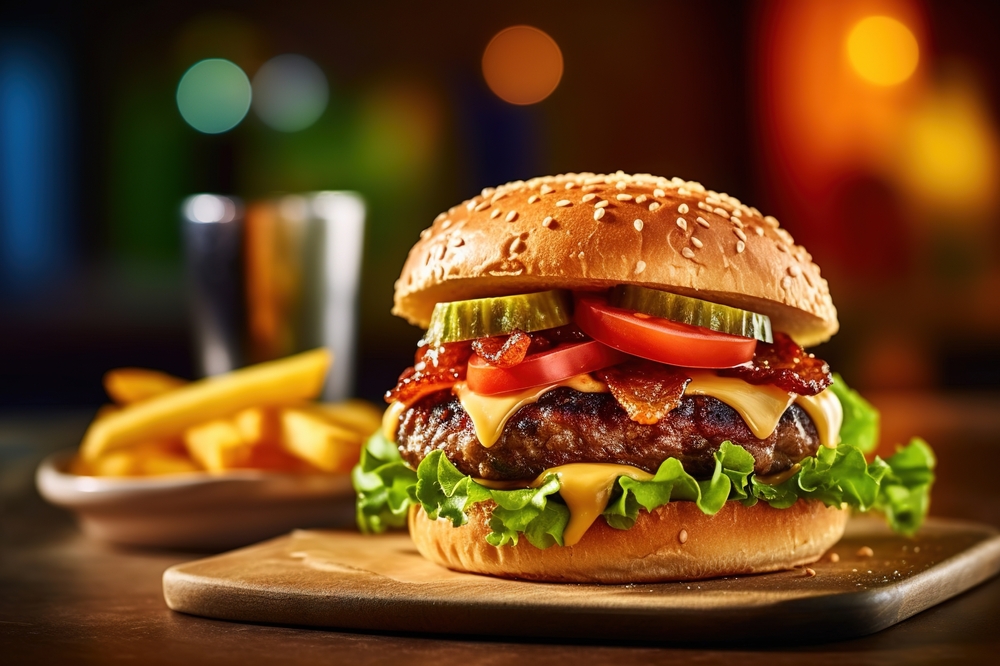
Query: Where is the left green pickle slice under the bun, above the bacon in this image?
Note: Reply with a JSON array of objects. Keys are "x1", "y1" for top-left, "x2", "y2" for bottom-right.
[{"x1": 424, "y1": 290, "x2": 573, "y2": 346}]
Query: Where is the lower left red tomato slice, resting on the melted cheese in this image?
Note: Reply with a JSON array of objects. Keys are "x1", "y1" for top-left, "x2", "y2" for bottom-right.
[{"x1": 465, "y1": 340, "x2": 628, "y2": 395}]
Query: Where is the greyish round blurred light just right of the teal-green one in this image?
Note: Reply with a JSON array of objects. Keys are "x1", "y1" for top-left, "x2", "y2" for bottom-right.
[{"x1": 253, "y1": 53, "x2": 330, "y2": 132}]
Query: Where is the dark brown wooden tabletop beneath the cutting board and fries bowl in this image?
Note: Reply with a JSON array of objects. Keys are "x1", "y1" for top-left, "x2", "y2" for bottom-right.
[{"x1": 0, "y1": 408, "x2": 1000, "y2": 666}]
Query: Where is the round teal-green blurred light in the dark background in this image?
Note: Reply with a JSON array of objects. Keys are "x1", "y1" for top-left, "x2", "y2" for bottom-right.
[{"x1": 177, "y1": 58, "x2": 251, "y2": 134}]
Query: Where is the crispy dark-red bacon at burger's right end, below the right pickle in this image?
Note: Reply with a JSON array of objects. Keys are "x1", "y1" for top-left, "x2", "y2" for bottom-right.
[{"x1": 719, "y1": 333, "x2": 833, "y2": 395}]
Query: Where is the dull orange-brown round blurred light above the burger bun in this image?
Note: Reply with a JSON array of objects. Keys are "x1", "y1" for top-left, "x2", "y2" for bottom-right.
[{"x1": 483, "y1": 25, "x2": 563, "y2": 105}]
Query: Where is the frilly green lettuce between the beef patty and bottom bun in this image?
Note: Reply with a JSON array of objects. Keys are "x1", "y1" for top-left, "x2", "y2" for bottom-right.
[{"x1": 352, "y1": 377, "x2": 935, "y2": 548}]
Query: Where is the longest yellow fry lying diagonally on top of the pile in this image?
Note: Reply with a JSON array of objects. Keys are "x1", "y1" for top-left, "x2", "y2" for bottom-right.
[{"x1": 80, "y1": 349, "x2": 332, "y2": 462}]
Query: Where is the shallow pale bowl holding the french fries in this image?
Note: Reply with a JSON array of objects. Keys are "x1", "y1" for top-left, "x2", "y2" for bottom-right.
[{"x1": 35, "y1": 450, "x2": 354, "y2": 550}]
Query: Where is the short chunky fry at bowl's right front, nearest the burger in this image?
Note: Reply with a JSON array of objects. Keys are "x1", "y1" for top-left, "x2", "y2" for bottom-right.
[{"x1": 281, "y1": 408, "x2": 364, "y2": 472}]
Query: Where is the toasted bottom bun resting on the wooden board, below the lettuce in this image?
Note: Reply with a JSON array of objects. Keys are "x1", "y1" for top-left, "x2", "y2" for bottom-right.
[{"x1": 409, "y1": 500, "x2": 849, "y2": 583}]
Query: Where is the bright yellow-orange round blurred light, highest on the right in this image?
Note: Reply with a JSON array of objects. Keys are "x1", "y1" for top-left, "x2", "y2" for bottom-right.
[{"x1": 847, "y1": 16, "x2": 920, "y2": 86}]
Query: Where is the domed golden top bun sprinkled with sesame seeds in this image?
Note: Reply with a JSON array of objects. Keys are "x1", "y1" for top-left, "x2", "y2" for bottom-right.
[{"x1": 393, "y1": 171, "x2": 839, "y2": 346}]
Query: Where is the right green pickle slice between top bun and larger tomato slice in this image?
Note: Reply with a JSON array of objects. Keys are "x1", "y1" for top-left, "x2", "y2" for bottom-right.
[{"x1": 608, "y1": 285, "x2": 774, "y2": 343}]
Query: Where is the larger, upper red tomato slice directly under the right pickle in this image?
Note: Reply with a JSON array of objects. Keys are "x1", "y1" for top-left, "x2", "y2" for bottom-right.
[{"x1": 574, "y1": 296, "x2": 757, "y2": 368}]
